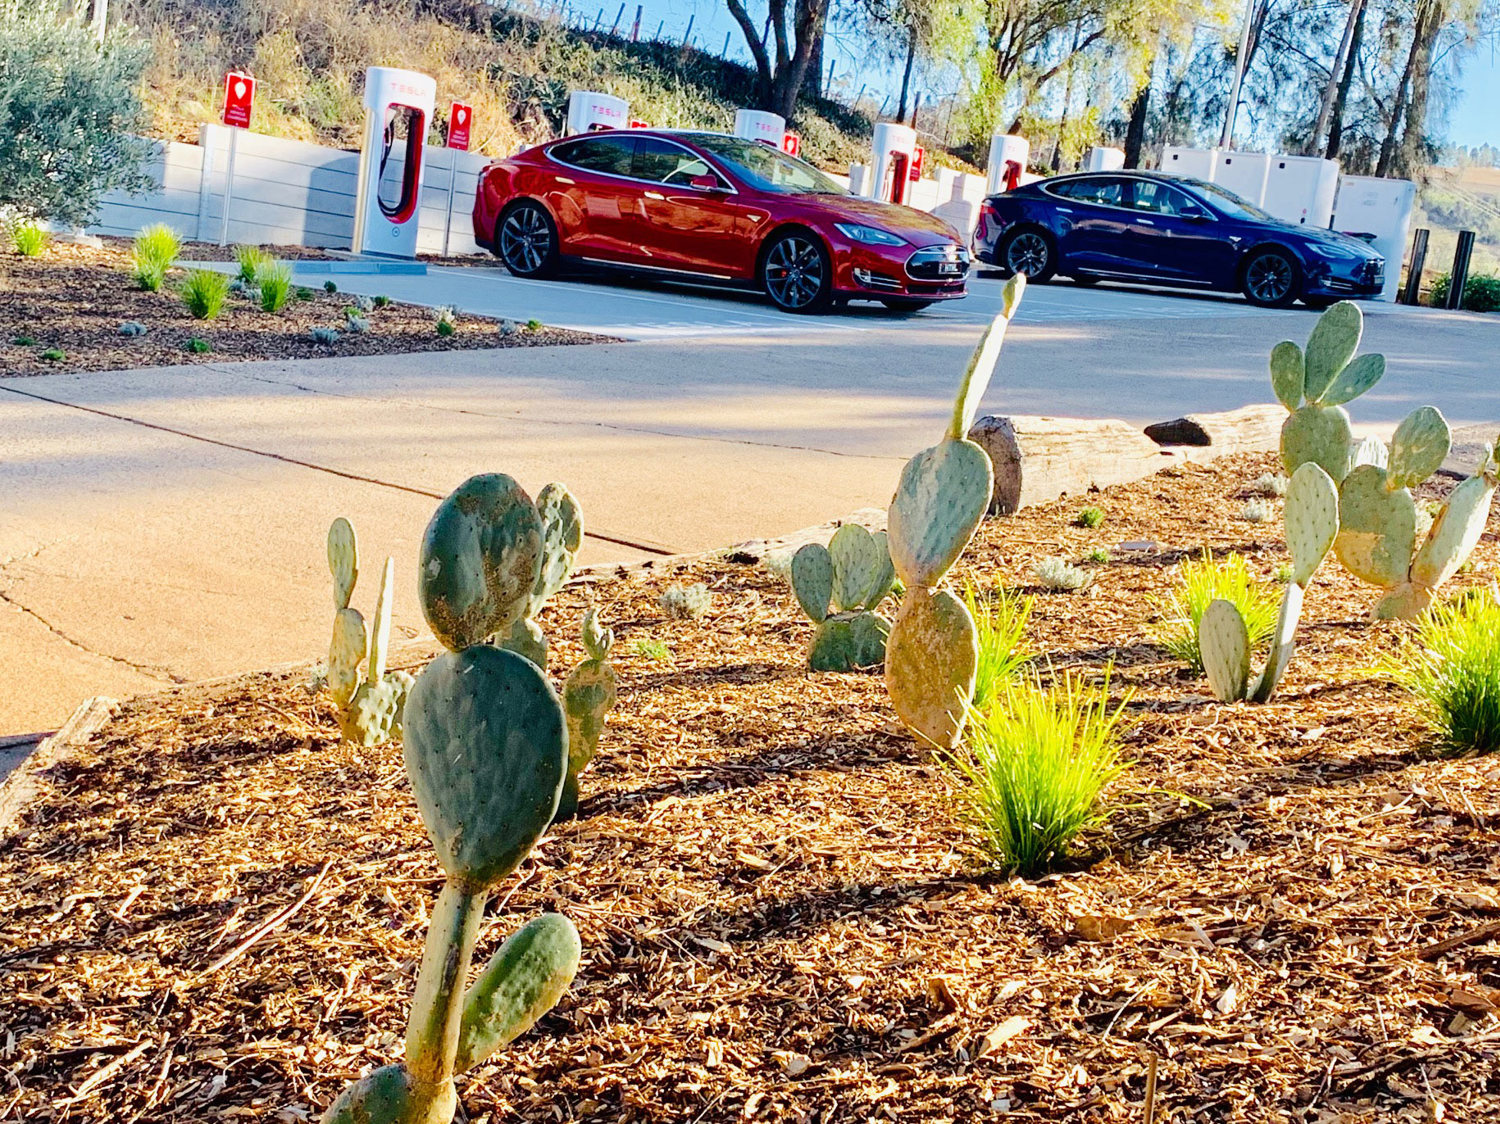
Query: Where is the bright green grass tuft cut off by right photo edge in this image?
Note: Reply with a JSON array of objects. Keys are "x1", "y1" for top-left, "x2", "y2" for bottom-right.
[{"x1": 1386, "y1": 591, "x2": 1500, "y2": 753}]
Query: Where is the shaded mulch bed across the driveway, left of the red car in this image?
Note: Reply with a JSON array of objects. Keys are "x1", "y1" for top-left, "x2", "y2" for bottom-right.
[{"x1": 0, "y1": 239, "x2": 605, "y2": 378}]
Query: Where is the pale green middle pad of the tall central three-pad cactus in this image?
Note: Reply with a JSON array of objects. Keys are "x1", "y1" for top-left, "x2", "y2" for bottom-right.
[{"x1": 890, "y1": 438, "x2": 995, "y2": 588}]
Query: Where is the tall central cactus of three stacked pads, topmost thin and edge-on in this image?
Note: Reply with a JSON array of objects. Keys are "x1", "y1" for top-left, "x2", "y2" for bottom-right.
[{"x1": 885, "y1": 275, "x2": 1026, "y2": 749}]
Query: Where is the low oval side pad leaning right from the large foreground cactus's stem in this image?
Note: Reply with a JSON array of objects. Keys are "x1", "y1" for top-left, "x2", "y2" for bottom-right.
[{"x1": 455, "y1": 914, "x2": 584, "y2": 1073}]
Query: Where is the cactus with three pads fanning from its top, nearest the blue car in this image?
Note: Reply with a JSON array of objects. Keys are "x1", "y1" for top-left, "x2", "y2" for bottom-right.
[{"x1": 1271, "y1": 300, "x2": 1386, "y2": 483}]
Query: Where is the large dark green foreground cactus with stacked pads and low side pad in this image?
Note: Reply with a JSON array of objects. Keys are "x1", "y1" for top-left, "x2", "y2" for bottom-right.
[{"x1": 323, "y1": 474, "x2": 581, "y2": 1124}]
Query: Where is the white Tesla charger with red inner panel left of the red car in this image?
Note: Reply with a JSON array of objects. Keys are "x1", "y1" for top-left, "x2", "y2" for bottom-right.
[{"x1": 354, "y1": 66, "x2": 438, "y2": 258}]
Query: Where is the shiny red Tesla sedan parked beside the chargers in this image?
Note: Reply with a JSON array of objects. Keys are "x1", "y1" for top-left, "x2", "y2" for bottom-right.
[{"x1": 474, "y1": 129, "x2": 969, "y2": 312}]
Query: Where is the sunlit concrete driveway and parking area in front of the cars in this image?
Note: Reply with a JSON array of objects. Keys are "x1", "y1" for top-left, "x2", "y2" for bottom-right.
[{"x1": 0, "y1": 266, "x2": 1500, "y2": 737}]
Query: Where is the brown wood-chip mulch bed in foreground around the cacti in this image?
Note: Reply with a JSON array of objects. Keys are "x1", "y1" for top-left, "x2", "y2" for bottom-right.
[{"x1": 0, "y1": 456, "x2": 1500, "y2": 1124}]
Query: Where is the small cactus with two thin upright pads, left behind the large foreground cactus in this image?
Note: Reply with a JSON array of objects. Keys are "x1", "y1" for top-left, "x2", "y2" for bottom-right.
[{"x1": 327, "y1": 516, "x2": 413, "y2": 746}]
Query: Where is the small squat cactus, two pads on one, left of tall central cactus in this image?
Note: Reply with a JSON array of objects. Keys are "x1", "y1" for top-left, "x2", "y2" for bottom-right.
[{"x1": 792, "y1": 524, "x2": 896, "y2": 671}]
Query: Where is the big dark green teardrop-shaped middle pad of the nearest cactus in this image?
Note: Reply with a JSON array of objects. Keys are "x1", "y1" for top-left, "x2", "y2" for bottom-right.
[{"x1": 404, "y1": 645, "x2": 567, "y2": 888}]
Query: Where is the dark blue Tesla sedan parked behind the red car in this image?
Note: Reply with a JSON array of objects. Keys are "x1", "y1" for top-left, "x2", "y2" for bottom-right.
[{"x1": 974, "y1": 171, "x2": 1386, "y2": 308}]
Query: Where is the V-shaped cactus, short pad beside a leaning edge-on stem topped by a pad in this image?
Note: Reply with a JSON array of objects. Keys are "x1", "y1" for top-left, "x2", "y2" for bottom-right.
[{"x1": 1199, "y1": 461, "x2": 1338, "y2": 702}]
